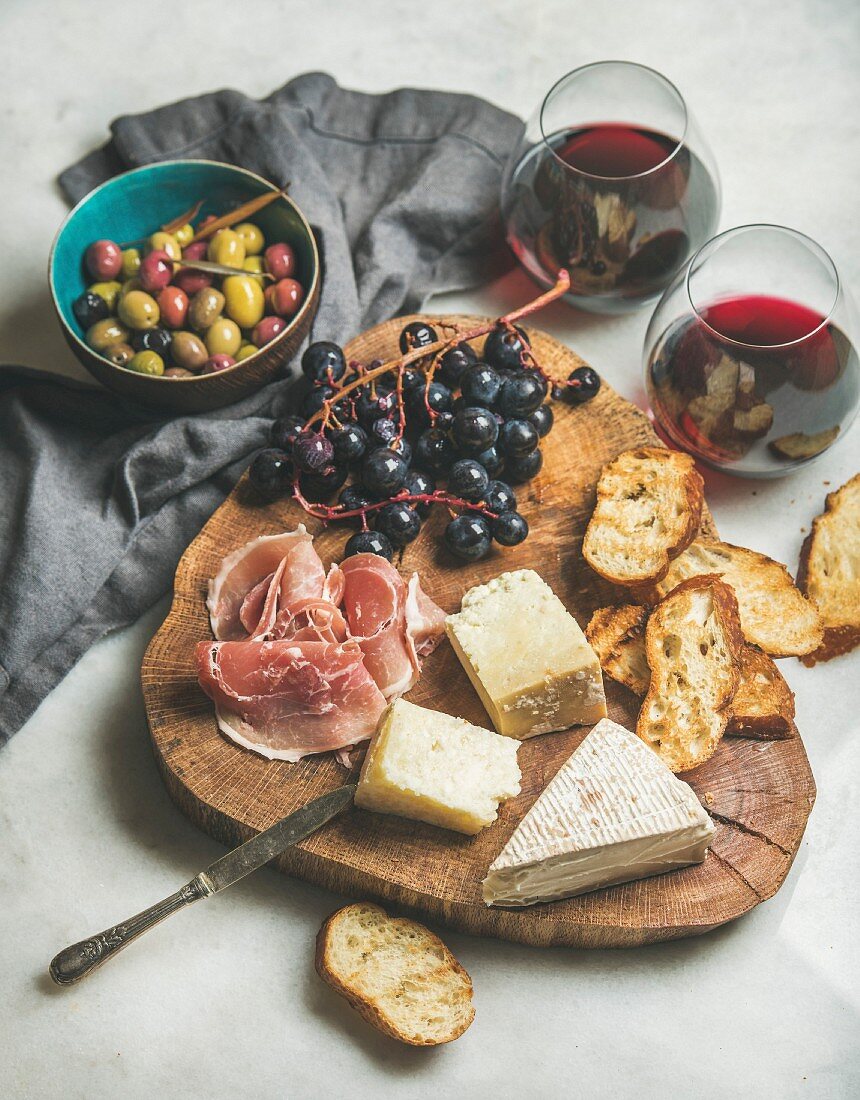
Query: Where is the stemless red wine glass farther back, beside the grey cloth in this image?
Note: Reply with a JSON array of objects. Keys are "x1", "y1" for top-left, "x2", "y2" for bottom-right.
[{"x1": 501, "y1": 62, "x2": 720, "y2": 314}]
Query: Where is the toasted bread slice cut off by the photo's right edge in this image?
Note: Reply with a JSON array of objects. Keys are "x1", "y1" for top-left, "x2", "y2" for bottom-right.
[{"x1": 798, "y1": 474, "x2": 860, "y2": 664}]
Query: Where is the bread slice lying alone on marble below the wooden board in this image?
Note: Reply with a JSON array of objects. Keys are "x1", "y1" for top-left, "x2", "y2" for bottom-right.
[{"x1": 316, "y1": 902, "x2": 475, "y2": 1046}]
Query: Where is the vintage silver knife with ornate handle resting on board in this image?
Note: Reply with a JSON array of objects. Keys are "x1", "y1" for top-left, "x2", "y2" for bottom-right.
[{"x1": 49, "y1": 783, "x2": 355, "y2": 986}]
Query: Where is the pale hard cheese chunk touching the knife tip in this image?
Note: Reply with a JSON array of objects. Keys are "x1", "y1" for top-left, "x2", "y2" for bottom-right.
[{"x1": 355, "y1": 699, "x2": 520, "y2": 835}]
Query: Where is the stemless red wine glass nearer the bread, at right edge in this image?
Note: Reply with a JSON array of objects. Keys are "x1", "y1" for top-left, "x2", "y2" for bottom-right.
[{"x1": 644, "y1": 226, "x2": 860, "y2": 477}]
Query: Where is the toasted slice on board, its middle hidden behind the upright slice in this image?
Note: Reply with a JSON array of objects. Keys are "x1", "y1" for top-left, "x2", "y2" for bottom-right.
[{"x1": 585, "y1": 604, "x2": 794, "y2": 741}]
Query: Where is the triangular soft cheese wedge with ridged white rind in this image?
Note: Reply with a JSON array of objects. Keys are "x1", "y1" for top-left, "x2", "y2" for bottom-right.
[{"x1": 484, "y1": 718, "x2": 714, "y2": 905}]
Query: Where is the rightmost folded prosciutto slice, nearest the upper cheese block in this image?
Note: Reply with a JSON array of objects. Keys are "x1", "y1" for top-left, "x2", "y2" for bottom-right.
[{"x1": 341, "y1": 553, "x2": 444, "y2": 699}]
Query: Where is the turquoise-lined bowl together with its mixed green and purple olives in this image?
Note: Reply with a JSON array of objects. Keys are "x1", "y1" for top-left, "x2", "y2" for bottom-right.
[{"x1": 48, "y1": 161, "x2": 321, "y2": 413}]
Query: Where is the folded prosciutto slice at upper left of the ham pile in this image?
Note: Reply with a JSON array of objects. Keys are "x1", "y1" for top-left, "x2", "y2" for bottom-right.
[{"x1": 207, "y1": 524, "x2": 327, "y2": 641}]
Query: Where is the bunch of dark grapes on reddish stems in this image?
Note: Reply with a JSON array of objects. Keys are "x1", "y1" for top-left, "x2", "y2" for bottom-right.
[{"x1": 250, "y1": 322, "x2": 599, "y2": 561}]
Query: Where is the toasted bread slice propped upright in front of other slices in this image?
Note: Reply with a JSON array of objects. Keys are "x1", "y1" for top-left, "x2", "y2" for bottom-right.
[{"x1": 636, "y1": 575, "x2": 743, "y2": 771}]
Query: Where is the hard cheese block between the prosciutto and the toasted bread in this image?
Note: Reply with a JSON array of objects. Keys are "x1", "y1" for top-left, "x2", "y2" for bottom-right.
[{"x1": 445, "y1": 569, "x2": 606, "y2": 740}]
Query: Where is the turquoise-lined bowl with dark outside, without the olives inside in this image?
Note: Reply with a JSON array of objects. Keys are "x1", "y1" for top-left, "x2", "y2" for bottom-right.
[{"x1": 48, "y1": 161, "x2": 320, "y2": 413}]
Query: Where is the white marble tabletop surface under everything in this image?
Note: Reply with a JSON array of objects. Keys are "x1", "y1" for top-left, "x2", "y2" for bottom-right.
[{"x1": 0, "y1": 0, "x2": 860, "y2": 1100}]
